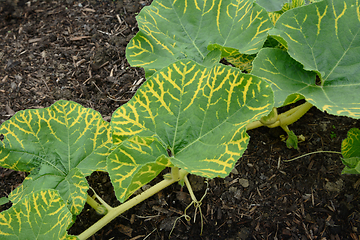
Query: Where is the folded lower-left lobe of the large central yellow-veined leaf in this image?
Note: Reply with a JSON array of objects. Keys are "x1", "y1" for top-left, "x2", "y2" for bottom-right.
[{"x1": 107, "y1": 136, "x2": 172, "y2": 202}]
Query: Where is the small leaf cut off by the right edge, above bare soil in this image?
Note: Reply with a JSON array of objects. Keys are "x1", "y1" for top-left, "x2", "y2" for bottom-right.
[{"x1": 341, "y1": 128, "x2": 360, "y2": 174}]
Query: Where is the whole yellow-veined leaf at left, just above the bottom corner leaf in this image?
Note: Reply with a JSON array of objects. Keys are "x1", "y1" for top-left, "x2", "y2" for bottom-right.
[{"x1": 0, "y1": 100, "x2": 111, "y2": 214}]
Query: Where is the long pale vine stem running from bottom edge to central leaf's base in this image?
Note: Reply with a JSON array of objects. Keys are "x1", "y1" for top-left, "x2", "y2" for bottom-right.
[{"x1": 77, "y1": 167, "x2": 188, "y2": 240}]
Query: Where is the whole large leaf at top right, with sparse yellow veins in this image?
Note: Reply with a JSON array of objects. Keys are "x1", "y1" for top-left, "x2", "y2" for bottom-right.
[{"x1": 252, "y1": 0, "x2": 360, "y2": 118}]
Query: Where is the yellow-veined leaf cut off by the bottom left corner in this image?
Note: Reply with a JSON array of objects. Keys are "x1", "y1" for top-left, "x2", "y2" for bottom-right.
[{"x1": 0, "y1": 189, "x2": 77, "y2": 240}]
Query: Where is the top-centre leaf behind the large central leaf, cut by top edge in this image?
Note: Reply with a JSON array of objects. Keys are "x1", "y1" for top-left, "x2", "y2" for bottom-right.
[{"x1": 126, "y1": 0, "x2": 273, "y2": 77}]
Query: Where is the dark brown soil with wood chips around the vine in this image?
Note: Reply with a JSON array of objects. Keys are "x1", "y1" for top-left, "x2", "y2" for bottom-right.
[{"x1": 0, "y1": 0, "x2": 360, "y2": 240}]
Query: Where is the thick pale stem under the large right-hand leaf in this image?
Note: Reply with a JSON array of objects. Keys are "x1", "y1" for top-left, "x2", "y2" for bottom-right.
[{"x1": 246, "y1": 102, "x2": 313, "y2": 130}]
